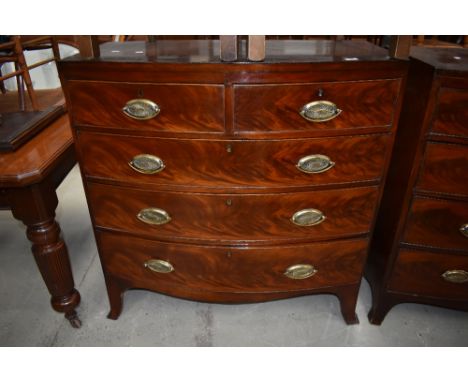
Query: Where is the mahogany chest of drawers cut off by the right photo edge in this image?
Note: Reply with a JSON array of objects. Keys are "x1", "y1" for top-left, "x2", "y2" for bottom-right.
[{"x1": 366, "y1": 47, "x2": 468, "y2": 324}]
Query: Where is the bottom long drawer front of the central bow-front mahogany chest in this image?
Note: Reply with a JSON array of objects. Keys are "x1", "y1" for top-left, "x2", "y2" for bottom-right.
[{"x1": 98, "y1": 232, "x2": 367, "y2": 294}]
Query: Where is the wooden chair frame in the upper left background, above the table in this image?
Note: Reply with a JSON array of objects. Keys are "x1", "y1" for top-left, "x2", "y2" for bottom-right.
[{"x1": 0, "y1": 36, "x2": 60, "y2": 111}]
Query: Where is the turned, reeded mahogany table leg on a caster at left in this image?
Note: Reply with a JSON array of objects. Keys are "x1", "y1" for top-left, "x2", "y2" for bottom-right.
[{"x1": 11, "y1": 185, "x2": 81, "y2": 328}]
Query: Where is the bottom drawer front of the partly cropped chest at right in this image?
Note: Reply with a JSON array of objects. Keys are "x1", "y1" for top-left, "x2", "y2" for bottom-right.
[{"x1": 388, "y1": 250, "x2": 468, "y2": 299}]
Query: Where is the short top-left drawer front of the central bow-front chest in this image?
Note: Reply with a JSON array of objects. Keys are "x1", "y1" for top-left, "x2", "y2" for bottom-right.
[{"x1": 68, "y1": 81, "x2": 224, "y2": 133}]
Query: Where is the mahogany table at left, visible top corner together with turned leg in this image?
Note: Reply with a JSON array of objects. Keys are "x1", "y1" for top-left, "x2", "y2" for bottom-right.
[{"x1": 0, "y1": 115, "x2": 81, "y2": 327}]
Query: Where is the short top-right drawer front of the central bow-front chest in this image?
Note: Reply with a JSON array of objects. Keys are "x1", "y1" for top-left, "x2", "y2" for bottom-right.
[{"x1": 234, "y1": 80, "x2": 400, "y2": 133}]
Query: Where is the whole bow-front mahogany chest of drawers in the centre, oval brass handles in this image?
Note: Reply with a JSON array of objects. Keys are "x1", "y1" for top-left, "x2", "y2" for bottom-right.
[{"x1": 59, "y1": 40, "x2": 407, "y2": 323}]
